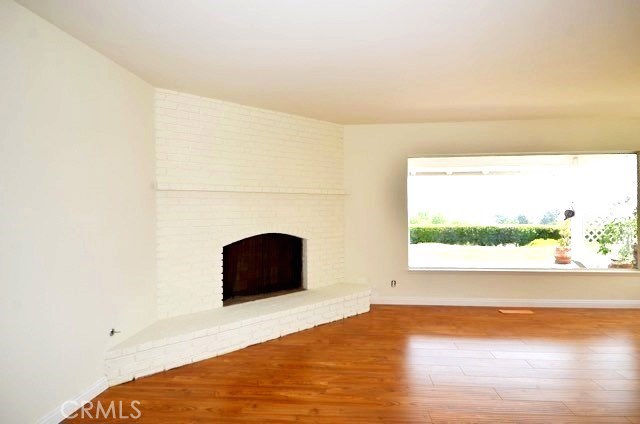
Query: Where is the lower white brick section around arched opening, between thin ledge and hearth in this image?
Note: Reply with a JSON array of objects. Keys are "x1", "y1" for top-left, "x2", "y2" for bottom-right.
[{"x1": 157, "y1": 191, "x2": 343, "y2": 318}]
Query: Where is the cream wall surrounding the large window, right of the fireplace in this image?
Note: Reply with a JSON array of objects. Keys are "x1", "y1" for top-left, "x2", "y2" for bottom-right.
[{"x1": 344, "y1": 119, "x2": 640, "y2": 304}]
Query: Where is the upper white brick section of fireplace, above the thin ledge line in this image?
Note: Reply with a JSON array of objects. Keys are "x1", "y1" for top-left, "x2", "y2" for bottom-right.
[{"x1": 156, "y1": 90, "x2": 343, "y2": 195}]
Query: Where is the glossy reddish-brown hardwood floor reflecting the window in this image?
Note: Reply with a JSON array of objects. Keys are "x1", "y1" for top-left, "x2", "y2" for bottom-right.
[{"x1": 70, "y1": 306, "x2": 640, "y2": 424}]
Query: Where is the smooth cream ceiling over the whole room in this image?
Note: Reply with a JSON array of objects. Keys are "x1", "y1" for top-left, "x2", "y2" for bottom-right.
[{"x1": 18, "y1": 0, "x2": 640, "y2": 124}]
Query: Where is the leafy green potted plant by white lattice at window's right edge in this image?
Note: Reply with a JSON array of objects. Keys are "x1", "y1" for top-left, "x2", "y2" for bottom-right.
[{"x1": 598, "y1": 209, "x2": 638, "y2": 268}]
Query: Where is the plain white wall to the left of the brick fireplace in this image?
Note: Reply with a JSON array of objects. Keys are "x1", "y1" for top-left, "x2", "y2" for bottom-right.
[{"x1": 0, "y1": 0, "x2": 155, "y2": 423}]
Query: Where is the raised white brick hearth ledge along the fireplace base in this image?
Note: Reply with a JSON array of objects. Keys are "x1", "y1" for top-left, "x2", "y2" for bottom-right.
[{"x1": 105, "y1": 283, "x2": 371, "y2": 386}]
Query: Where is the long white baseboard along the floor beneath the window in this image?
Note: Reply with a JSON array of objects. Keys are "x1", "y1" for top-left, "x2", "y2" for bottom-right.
[{"x1": 371, "y1": 294, "x2": 640, "y2": 309}]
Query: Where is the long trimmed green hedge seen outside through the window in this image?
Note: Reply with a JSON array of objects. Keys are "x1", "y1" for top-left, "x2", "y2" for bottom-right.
[{"x1": 409, "y1": 225, "x2": 560, "y2": 246}]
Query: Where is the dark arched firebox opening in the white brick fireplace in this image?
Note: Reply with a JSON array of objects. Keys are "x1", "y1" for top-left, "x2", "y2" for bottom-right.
[{"x1": 222, "y1": 233, "x2": 303, "y2": 306}]
